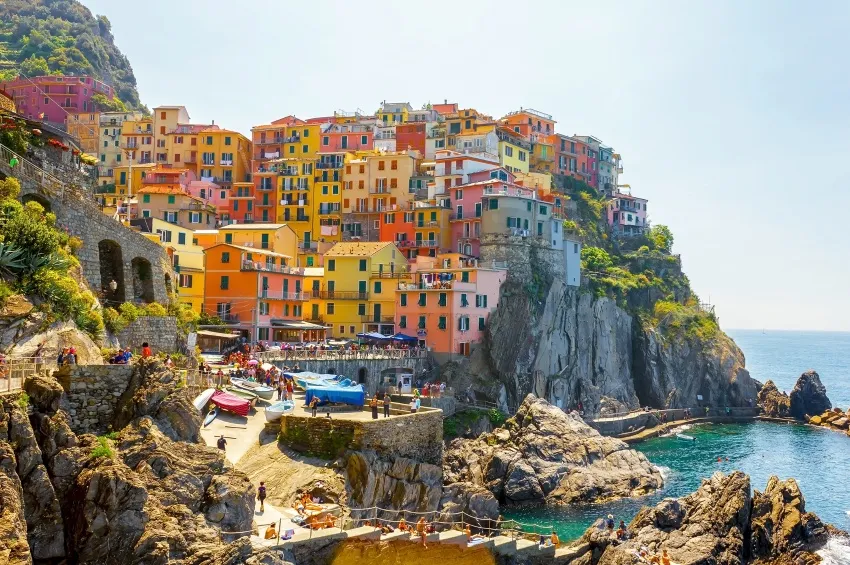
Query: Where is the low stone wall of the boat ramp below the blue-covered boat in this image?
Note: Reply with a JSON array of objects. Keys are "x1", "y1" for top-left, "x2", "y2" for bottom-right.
[{"x1": 279, "y1": 410, "x2": 443, "y2": 465}]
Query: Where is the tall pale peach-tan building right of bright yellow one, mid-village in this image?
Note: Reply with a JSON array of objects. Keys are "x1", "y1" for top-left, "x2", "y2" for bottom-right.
[{"x1": 342, "y1": 151, "x2": 420, "y2": 241}]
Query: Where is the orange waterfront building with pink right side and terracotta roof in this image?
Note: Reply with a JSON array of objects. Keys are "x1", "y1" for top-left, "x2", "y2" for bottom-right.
[{"x1": 204, "y1": 243, "x2": 325, "y2": 342}]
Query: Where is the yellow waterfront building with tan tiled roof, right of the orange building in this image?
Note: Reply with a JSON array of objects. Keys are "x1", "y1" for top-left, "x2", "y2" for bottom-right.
[{"x1": 319, "y1": 242, "x2": 407, "y2": 339}]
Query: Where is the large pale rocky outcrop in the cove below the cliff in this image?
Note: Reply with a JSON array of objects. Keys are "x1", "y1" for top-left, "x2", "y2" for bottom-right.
[{"x1": 443, "y1": 395, "x2": 663, "y2": 504}]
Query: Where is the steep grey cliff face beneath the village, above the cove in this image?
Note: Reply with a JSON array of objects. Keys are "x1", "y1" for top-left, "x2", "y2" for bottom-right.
[{"x1": 470, "y1": 275, "x2": 758, "y2": 414}]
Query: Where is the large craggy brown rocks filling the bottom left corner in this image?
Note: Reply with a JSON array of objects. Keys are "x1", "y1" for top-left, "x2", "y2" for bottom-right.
[{"x1": 0, "y1": 362, "x2": 262, "y2": 565}]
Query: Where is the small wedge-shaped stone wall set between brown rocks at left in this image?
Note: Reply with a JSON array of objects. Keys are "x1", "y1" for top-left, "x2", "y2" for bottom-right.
[{"x1": 61, "y1": 365, "x2": 134, "y2": 434}]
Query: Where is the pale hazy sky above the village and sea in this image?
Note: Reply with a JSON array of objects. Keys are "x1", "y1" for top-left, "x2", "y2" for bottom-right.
[{"x1": 83, "y1": 0, "x2": 850, "y2": 330}]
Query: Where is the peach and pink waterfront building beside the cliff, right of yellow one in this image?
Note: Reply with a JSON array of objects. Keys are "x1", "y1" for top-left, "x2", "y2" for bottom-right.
[{"x1": 395, "y1": 253, "x2": 507, "y2": 361}]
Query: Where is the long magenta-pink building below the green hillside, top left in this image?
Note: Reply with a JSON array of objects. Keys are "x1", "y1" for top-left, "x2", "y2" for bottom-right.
[{"x1": 0, "y1": 76, "x2": 113, "y2": 124}]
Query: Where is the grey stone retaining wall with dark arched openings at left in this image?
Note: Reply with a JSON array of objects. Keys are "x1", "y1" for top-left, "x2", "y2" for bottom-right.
[{"x1": 11, "y1": 169, "x2": 176, "y2": 303}]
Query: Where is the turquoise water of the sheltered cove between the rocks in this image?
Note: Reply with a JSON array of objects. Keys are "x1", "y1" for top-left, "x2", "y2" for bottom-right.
[{"x1": 505, "y1": 422, "x2": 850, "y2": 540}]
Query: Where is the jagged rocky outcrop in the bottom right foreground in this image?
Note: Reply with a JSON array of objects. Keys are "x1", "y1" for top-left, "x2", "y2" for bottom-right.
[{"x1": 574, "y1": 471, "x2": 834, "y2": 565}]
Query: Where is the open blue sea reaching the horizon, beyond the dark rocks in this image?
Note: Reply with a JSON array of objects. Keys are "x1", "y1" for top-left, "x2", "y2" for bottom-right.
[{"x1": 726, "y1": 330, "x2": 850, "y2": 409}]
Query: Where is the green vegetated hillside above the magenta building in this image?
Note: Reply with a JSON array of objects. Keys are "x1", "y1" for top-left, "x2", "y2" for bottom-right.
[{"x1": 0, "y1": 0, "x2": 142, "y2": 110}]
